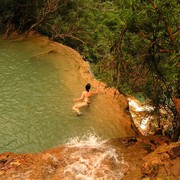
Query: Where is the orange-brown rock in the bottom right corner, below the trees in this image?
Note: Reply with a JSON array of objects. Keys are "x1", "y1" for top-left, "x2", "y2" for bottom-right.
[{"x1": 141, "y1": 143, "x2": 180, "y2": 177}]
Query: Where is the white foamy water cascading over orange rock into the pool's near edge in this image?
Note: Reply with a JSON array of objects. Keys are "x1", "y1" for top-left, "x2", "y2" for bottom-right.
[{"x1": 64, "y1": 135, "x2": 129, "y2": 180}]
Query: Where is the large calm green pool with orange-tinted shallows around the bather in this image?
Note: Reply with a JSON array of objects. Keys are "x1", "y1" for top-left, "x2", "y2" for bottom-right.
[{"x1": 0, "y1": 38, "x2": 130, "y2": 153}]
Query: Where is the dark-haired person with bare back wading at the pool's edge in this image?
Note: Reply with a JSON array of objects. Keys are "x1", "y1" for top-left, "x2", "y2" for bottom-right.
[{"x1": 72, "y1": 83, "x2": 99, "y2": 115}]
